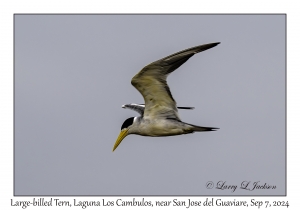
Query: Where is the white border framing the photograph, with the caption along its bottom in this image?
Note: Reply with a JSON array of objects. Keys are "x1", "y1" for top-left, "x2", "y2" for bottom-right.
[{"x1": 0, "y1": 0, "x2": 300, "y2": 209}]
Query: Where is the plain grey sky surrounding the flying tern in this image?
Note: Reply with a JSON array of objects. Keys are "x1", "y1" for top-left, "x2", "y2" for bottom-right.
[{"x1": 14, "y1": 15, "x2": 286, "y2": 195}]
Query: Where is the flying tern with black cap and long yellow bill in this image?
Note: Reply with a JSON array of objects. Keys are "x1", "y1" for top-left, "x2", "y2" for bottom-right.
[{"x1": 113, "y1": 42, "x2": 220, "y2": 151}]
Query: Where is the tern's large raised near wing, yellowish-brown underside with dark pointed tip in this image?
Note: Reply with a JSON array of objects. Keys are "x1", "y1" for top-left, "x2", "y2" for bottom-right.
[{"x1": 131, "y1": 42, "x2": 219, "y2": 120}]
